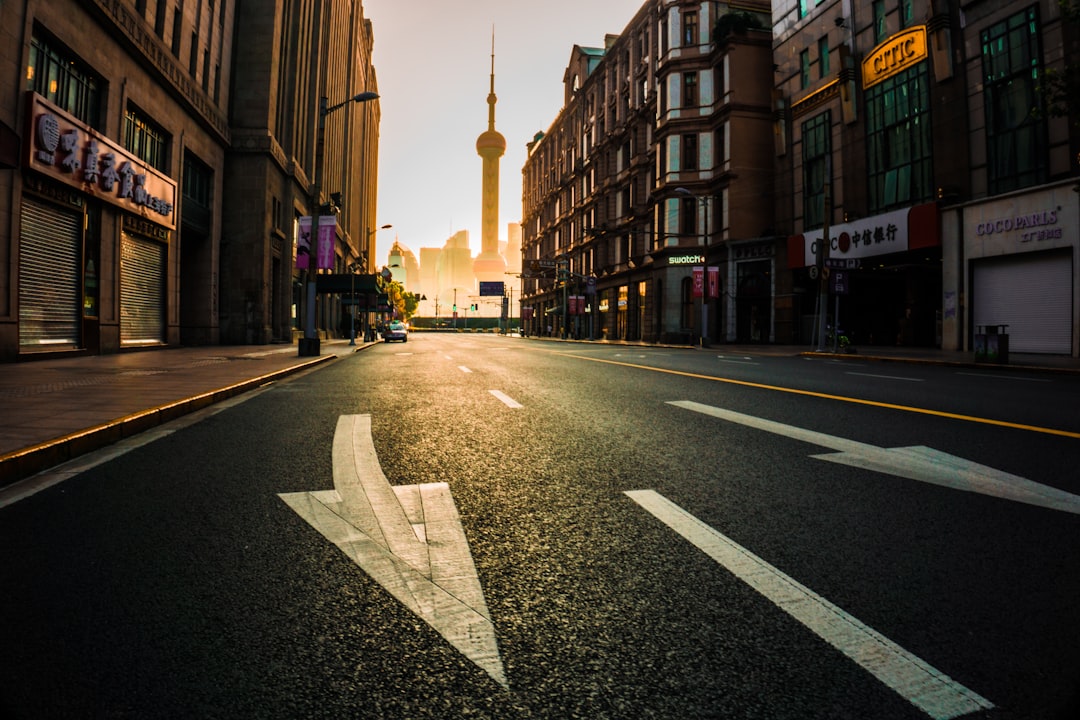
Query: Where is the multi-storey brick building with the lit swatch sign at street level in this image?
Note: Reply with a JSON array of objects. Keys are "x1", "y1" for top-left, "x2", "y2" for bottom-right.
[{"x1": 522, "y1": 0, "x2": 792, "y2": 343}]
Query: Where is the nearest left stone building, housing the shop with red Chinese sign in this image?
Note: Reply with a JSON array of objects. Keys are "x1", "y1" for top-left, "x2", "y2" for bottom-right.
[{"x1": 0, "y1": 0, "x2": 234, "y2": 361}]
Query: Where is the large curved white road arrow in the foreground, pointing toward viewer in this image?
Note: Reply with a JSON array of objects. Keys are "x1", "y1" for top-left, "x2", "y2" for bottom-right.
[{"x1": 279, "y1": 415, "x2": 510, "y2": 688}]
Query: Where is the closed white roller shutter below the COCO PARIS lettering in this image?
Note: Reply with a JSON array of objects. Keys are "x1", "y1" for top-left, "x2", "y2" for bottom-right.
[{"x1": 972, "y1": 250, "x2": 1072, "y2": 355}]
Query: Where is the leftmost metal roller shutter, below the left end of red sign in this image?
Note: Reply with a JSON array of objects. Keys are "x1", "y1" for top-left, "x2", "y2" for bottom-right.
[{"x1": 18, "y1": 198, "x2": 82, "y2": 351}]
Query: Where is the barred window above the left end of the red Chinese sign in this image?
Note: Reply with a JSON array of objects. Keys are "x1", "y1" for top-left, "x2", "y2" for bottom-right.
[{"x1": 26, "y1": 32, "x2": 105, "y2": 127}]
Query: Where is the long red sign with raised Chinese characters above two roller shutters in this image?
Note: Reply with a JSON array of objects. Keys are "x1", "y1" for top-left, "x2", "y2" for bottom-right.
[{"x1": 25, "y1": 93, "x2": 176, "y2": 230}]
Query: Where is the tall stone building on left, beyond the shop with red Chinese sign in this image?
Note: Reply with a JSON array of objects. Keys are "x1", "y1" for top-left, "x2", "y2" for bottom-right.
[{"x1": 220, "y1": 0, "x2": 380, "y2": 343}]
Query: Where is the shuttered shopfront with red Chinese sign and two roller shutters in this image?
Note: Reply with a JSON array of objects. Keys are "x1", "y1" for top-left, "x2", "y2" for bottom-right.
[{"x1": 17, "y1": 95, "x2": 177, "y2": 354}]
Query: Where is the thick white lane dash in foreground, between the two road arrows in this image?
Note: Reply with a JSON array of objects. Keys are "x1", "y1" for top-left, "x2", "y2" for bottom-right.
[{"x1": 626, "y1": 490, "x2": 994, "y2": 720}]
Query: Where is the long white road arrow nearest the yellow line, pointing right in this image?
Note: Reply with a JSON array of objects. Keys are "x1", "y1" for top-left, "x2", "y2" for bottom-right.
[{"x1": 669, "y1": 400, "x2": 1080, "y2": 515}]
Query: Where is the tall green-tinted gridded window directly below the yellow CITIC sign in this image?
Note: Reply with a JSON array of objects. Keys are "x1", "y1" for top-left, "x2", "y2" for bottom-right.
[{"x1": 866, "y1": 63, "x2": 933, "y2": 213}]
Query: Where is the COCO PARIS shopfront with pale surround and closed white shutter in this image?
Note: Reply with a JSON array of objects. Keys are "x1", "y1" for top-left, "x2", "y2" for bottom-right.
[{"x1": 943, "y1": 180, "x2": 1080, "y2": 357}]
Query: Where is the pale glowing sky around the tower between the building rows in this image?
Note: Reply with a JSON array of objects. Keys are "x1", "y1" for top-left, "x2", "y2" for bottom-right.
[{"x1": 364, "y1": 0, "x2": 645, "y2": 267}]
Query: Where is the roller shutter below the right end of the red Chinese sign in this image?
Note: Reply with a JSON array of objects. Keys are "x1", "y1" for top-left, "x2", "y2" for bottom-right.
[{"x1": 120, "y1": 233, "x2": 166, "y2": 345}]
